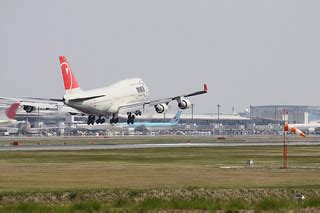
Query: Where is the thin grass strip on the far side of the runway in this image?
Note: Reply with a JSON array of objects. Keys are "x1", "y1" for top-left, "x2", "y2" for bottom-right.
[{"x1": 0, "y1": 135, "x2": 320, "y2": 146}]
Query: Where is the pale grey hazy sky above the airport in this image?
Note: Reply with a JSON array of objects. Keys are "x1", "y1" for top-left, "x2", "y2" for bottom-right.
[{"x1": 0, "y1": 0, "x2": 320, "y2": 113}]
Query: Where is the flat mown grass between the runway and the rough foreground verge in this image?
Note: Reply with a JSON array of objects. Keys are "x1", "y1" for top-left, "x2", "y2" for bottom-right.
[{"x1": 0, "y1": 146, "x2": 320, "y2": 191}]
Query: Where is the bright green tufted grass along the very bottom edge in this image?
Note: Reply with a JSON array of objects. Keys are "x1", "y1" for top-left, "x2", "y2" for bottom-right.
[{"x1": 0, "y1": 198, "x2": 319, "y2": 213}]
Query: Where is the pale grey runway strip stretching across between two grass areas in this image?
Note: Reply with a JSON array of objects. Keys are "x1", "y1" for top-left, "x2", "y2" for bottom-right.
[{"x1": 0, "y1": 142, "x2": 320, "y2": 151}]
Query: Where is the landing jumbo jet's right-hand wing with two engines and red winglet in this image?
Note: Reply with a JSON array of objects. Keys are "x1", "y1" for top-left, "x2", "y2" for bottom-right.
[{"x1": 119, "y1": 84, "x2": 208, "y2": 113}]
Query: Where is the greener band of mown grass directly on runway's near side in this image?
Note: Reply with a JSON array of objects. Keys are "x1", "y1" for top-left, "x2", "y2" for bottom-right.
[{"x1": 0, "y1": 146, "x2": 320, "y2": 167}]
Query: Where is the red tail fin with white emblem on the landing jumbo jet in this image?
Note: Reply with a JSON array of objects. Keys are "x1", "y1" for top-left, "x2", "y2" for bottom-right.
[{"x1": 59, "y1": 56, "x2": 81, "y2": 94}]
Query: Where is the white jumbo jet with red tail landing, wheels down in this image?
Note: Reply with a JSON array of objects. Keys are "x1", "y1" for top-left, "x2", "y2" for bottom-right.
[{"x1": 57, "y1": 56, "x2": 207, "y2": 125}]
